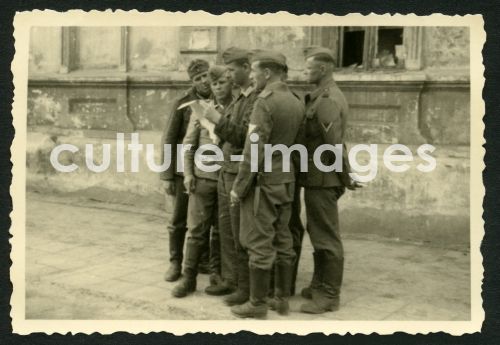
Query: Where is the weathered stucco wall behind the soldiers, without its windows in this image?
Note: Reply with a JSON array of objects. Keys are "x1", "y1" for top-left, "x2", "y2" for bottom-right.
[{"x1": 27, "y1": 27, "x2": 470, "y2": 245}]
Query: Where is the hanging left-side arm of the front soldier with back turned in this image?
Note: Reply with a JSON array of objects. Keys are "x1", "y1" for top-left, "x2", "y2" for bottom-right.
[{"x1": 233, "y1": 98, "x2": 273, "y2": 199}]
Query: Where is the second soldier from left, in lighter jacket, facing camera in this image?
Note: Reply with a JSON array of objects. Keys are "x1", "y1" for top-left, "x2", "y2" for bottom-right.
[{"x1": 172, "y1": 66, "x2": 233, "y2": 297}]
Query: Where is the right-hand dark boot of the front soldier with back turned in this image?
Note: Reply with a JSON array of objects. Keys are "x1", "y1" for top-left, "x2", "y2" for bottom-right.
[{"x1": 269, "y1": 263, "x2": 294, "y2": 315}]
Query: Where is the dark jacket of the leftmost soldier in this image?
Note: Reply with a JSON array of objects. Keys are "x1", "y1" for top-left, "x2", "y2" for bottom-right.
[{"x1": 160, "y1": 88, "x2": 208, "y2": 180}]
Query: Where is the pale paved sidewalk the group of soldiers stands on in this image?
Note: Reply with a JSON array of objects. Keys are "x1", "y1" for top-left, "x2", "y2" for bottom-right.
[{"x1": 26, "y1": 193, "x2": 470, "y2": 320}]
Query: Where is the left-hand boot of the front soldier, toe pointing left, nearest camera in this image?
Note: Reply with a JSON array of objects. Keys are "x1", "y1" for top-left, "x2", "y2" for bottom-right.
[{"x1": 231, "y1": 268, "x2": 271, "y2": 319}]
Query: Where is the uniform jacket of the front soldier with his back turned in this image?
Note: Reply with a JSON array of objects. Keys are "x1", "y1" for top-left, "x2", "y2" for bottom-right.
[{"x1": 233, "y1": 82, "x2": 304, "y2": 198}]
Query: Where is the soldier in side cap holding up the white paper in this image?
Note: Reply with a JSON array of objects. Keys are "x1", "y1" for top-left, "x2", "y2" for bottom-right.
[{"x1": 201, "y1": 47, "x2": 258, "y2": 306}]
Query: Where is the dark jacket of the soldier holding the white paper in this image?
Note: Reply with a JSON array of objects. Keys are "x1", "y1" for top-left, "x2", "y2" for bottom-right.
[{"x1": 215, "y1": 87, "x2": 258, "y2": 174}]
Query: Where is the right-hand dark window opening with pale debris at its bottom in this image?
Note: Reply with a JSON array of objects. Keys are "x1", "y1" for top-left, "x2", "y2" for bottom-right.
[{"x1": 374, "y1": 28, "x2": 404, "y2": 67}]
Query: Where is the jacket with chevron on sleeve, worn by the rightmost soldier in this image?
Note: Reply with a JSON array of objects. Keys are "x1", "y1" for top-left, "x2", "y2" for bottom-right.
[{"x1": 299, "y1": 79, "x2": 351, "y2": 187}]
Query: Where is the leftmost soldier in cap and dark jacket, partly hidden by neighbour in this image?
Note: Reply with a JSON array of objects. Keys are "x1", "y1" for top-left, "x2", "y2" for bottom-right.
[{"x1": 160, "y1": 59, "x2": 211, "y2": 282}]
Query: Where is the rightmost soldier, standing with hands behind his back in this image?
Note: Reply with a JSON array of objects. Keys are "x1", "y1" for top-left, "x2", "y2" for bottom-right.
[{"x1": 300, "y1": 47, "x2": 358, "y2": 314}]
